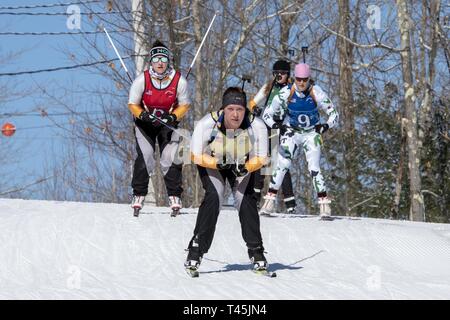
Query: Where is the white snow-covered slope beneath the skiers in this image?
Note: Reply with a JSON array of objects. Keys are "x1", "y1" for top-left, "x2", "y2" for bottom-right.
[{"x1": 0, "y1": 199, "x2": 450, "y2": 299}]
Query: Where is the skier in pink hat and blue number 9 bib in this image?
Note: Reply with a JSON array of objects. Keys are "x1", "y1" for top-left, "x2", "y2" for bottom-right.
[{"x1": 260, "y1": 63, "x2": 339, "y2": 219}]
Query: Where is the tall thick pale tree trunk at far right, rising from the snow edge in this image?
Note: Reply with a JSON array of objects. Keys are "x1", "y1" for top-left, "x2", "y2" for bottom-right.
[{"x1": 397, "y1": 0, "x2": 425, "y2": 221}]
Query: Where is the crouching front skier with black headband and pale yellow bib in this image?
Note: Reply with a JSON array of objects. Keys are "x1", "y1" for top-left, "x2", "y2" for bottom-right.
[{"x1": 185, "y1": 87, "x2": 268, "y2": 272}]
